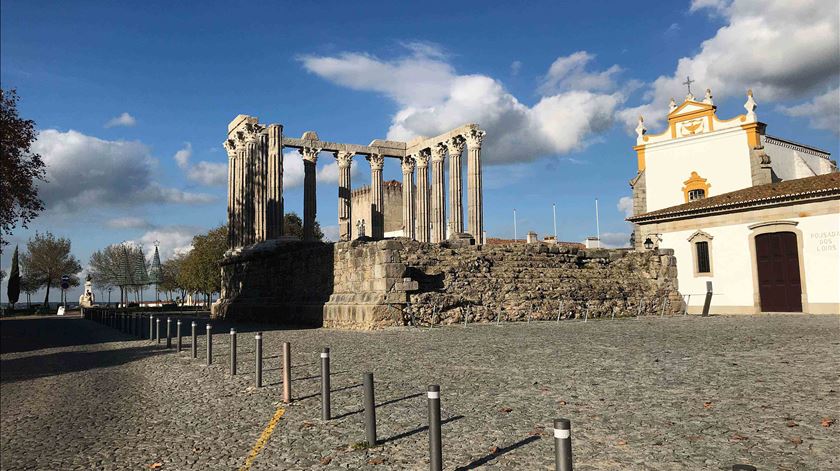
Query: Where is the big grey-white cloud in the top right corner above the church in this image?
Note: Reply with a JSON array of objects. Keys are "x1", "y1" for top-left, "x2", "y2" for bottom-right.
[{"x1": 621, "y1": 0, "x2": 840, "y2": 128}]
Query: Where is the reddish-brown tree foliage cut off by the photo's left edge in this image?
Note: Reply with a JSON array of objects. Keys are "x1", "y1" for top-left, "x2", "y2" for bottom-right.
[{"x1": 0, "y1": 89, "x2": 46, "y2": 249}]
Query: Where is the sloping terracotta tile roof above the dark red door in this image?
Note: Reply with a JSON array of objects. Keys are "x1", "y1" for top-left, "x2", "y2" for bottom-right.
[{"x1": 627, "y1": 172, "x2": 840, "y2": 223}]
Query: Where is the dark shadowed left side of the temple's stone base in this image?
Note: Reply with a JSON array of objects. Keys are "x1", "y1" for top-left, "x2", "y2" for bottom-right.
[{"x1": 212, "y1": 241, "x2": 334, "y2": 325}]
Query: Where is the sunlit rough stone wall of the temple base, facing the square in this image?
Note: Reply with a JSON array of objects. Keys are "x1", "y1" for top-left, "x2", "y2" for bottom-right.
[{"x1": 324, "y1": 239, "x2": 682, "y2": 328}]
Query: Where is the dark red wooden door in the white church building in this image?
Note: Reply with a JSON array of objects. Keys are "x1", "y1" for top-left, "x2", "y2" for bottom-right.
[{"x1": 755, "y1": 232, "x2": 802, "y2": 312}]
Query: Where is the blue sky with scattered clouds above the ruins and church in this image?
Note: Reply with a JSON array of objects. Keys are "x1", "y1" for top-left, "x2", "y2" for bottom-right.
[{"x1": 0, "y1": 0, "x2": 840, "y2": 302}]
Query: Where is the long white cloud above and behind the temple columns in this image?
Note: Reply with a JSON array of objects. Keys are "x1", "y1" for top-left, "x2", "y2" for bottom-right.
[{"x1": 301, "y1": 49, "x2": 624, "y2": 164}]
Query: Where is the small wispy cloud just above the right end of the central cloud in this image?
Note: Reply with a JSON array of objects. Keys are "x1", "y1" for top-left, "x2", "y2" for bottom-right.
[{"x1": 539, "y1": 51, "x2": 621, "y2": 94}]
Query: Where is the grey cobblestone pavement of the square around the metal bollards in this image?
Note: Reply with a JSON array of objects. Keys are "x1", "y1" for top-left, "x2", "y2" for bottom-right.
[{"x1": 0, "y1": 315, "x2": 840, "y2": 470}]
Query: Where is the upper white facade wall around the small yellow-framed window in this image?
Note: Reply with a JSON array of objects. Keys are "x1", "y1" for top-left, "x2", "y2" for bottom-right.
[{"x1": 645, "y1": 128, "x2": 752, "y2": 211}]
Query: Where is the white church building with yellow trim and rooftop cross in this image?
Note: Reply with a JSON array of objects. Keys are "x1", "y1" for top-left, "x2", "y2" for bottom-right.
[{"x1": 628, "y1": 90, "x2": 840, "y2": 314}]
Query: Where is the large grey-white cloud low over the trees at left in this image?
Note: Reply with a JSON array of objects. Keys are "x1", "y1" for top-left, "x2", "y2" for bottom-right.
[{"x1": 32, "y1": 129, "x2": 215, "y2": 214}]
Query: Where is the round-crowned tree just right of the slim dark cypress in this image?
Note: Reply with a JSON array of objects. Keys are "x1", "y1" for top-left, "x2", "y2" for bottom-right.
[{"x1": 22, "y1": 232, "x2": 82, "y2": 307}]
